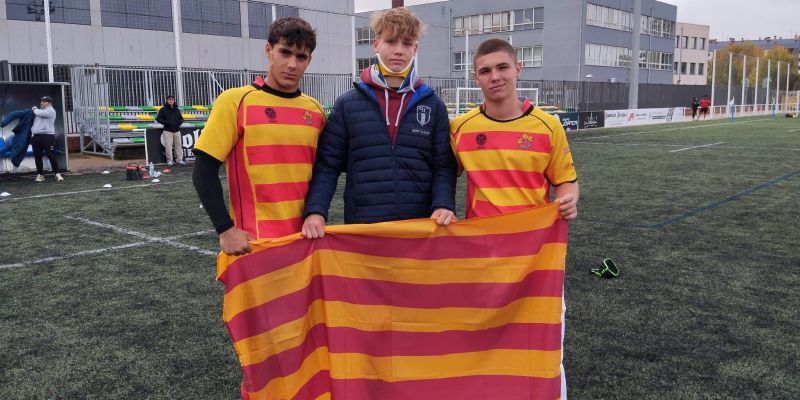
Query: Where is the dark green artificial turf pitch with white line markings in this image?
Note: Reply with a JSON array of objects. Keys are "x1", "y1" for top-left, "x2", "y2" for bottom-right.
[{"x1": 0, "y1": 117, "x2": 800, "y2": 400}]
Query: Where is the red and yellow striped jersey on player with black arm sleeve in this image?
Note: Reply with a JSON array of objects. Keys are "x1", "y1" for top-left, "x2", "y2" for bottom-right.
[{"x1": 195, "y1": 79, "x2": 325, "y2": 239}]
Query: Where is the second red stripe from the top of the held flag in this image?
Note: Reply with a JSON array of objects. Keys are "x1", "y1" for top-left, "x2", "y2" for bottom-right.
[{"x1": 227, "y1": 270, "x2": 564, "y2": 342}]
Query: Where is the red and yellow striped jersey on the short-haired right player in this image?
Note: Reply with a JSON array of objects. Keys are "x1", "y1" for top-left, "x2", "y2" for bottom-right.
[{"x1": 450, "y1": 99, "x2": 577, "y2": 218}]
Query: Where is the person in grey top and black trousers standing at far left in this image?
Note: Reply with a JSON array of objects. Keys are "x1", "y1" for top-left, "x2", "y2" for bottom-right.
[{"x1": 31, "y1": 96, "x2": 64, "y2": 182}]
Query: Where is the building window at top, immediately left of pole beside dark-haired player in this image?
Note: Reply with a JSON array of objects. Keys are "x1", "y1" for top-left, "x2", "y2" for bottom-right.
[{"x1": 100, "y1": 0, "x2": 172, "y2": 32}]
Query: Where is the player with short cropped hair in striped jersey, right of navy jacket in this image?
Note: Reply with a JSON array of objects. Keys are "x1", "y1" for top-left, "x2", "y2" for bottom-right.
[{"x1": 450, "y1": 39, "x2": 579, "y2": 220}]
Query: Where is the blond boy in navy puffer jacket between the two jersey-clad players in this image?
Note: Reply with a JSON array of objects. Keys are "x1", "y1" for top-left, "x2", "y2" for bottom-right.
[{"x1": 303, "y1": 7, "x2": 455, "y2": 238}]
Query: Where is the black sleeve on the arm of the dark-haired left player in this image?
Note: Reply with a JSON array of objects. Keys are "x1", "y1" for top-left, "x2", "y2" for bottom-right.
[{"x1": 192, "y1": 149, "x2": 233, "y2": 233}]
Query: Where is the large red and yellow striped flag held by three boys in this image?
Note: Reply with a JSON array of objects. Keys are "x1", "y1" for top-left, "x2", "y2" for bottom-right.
[{"x1": 217, "y1": 204, "x2": 567, "y2": 400}]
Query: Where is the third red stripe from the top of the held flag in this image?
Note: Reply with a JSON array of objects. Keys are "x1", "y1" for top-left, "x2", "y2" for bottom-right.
[{"x1": 243, "y1": 324, "x2": 561, "y2": 392}]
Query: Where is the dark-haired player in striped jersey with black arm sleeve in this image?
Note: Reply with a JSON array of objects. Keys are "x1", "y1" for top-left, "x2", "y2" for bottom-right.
[{"x1": 193, "y1": 17, "x2": 325, "y2": 255}]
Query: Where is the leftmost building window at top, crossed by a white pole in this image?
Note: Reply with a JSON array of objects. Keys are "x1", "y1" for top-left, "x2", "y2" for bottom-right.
[{"x1": 6, "y1": 0, "x2": 92, "y2": 25}]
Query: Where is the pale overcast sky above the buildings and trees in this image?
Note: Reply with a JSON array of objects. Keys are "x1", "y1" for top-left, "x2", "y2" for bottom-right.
[{"x1": 354, "y1": 0, "x2": 800, "y2": 40}]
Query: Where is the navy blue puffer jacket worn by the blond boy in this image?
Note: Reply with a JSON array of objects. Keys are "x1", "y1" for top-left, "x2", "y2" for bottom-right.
[{"x1": 303, "y1": 77, "x2": 456, "y2": 224}]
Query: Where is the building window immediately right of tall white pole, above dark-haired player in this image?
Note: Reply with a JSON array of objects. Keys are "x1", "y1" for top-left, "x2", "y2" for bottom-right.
[{"x1": 182, "y1": 0, "x2": 241, "y2": 37}]
